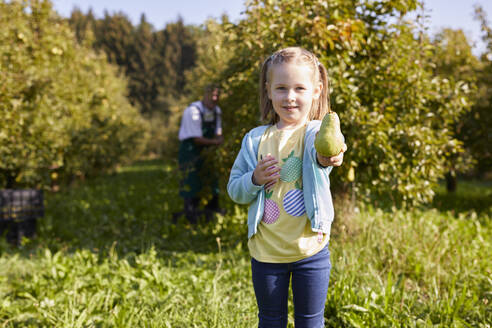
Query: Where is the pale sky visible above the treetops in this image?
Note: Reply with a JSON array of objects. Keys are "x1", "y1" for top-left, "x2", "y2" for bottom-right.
[{"x1": 52, "y1": 0, "x2": 492, "y2": 55}]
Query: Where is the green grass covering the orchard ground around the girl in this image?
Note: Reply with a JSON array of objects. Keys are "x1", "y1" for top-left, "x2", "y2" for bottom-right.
[{"x1": 0, "y1": 160, "x2": 492, "y2": 328}]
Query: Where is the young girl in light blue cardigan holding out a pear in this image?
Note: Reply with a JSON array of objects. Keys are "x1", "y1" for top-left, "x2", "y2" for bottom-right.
[{"x1": 227, "y1": 47, "x2": 347, "y2": 328}]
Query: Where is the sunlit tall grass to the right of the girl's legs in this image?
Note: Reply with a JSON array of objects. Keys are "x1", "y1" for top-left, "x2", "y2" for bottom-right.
[{"x1": 327, "y1": 208, "x2": 492, "y2": 327}]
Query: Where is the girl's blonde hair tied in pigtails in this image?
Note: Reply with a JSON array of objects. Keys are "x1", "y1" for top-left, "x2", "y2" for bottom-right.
[{"x1": 260, "y1": 47, "x2": 331, "y2": 124}]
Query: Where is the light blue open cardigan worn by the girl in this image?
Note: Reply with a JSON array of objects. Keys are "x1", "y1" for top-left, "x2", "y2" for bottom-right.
[{"x1": 227, "y1": 120, "x2": 334, "y2": 238}]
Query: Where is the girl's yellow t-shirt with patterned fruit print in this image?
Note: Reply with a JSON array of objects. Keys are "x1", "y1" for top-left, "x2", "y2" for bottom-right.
[{"x1": 248, "y1": 125, "x2": 328, "y2": 263}]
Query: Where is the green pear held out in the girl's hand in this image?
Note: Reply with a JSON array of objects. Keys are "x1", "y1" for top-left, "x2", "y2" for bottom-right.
[{"x1": 314, "y1": 112, "x2": 344, "y2": 157}]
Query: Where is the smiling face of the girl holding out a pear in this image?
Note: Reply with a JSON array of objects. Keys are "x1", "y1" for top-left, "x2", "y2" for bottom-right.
[{"x1": 267, "y1": 62, "x2": 322, "y2": 129}]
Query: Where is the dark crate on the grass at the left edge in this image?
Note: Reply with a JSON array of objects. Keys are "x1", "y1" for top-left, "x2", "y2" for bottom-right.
[{"x1": 0, "y1": 189, "x2": 44, "y2": 245}]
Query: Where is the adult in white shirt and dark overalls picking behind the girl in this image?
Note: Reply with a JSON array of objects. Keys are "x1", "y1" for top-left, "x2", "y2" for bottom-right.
[{"x1": 178, "y1": 85, "x2": 224, "y2": 224}]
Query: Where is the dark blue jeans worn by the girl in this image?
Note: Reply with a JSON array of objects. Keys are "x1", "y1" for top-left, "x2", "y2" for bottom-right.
[{"x1": 251, "y1": 246, "x2": 331, "y2": 328}]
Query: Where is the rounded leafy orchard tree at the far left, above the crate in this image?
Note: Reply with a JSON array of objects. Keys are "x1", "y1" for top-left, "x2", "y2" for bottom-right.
[{"x1": 0, "y1": 1, "x2": 146, "y2": 187}]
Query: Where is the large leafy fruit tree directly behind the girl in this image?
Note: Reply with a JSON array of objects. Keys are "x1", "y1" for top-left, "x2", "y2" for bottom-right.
[{"x1": 190, "y1": 0, "x2": 467, "y2": 206}]
